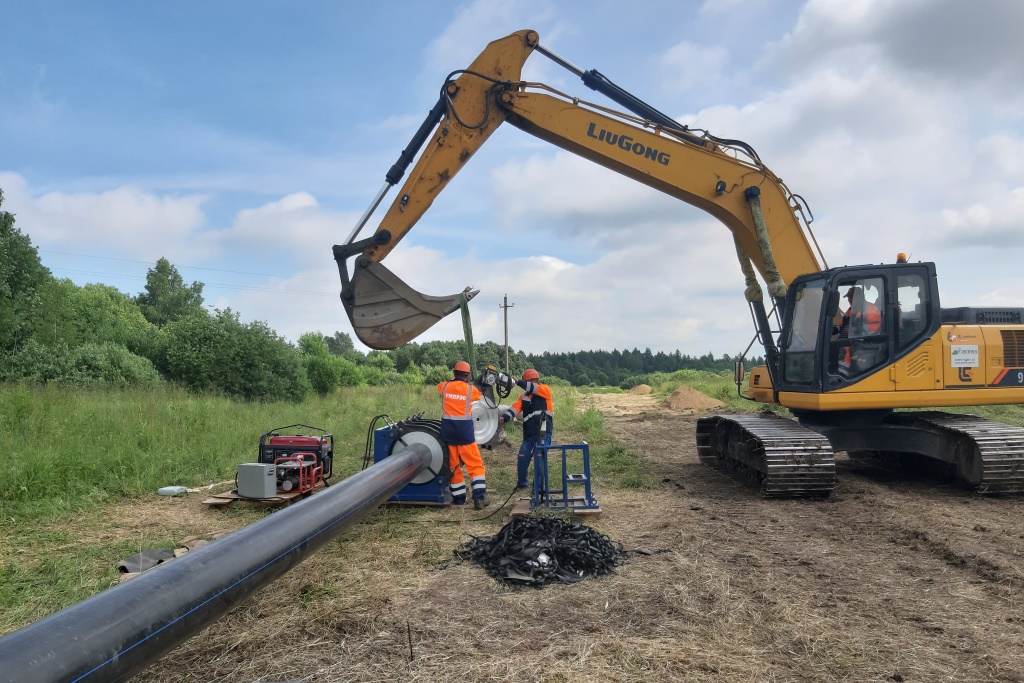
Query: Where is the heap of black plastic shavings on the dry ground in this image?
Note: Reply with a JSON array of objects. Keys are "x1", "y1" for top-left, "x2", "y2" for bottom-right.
[{"x1": 454, "y1": 517, "x2": 628, "y2": 588}]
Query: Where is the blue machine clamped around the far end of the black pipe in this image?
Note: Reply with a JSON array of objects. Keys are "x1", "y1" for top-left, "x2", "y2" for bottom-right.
[{"x1": 368, "y1": 413, "x2": 451, "y2": 505}]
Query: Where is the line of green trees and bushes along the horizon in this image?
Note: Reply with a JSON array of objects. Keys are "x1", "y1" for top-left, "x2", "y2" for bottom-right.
[{"x1": 0, "y1": 189, "x2": 753, "y2": 400}]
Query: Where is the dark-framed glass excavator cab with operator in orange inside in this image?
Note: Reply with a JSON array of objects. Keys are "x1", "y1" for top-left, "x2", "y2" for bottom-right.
[{"x1": 776, "y1": 263, "x2": 941, "y2": 393}]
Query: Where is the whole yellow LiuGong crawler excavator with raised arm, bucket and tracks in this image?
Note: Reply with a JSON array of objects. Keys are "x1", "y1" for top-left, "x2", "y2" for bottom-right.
[{"x1": 334, "y1": 31, "x2": 1024, "y2": 497}]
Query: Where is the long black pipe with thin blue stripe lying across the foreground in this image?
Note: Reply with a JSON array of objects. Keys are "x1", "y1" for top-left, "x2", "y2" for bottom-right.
[{"x1": 0, "y1": 443, "x2": 430, "y2": 683}]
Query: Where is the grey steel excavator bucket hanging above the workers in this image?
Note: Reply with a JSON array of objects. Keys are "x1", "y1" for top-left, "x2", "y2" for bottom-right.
[{"x1": 341, "y1": 258, "x2": 478, "y2": 351}]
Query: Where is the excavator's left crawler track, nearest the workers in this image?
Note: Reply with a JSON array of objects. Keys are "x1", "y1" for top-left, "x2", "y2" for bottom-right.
[{"x1": 696, "y1": 415, "x2": 836, "y2": 498}]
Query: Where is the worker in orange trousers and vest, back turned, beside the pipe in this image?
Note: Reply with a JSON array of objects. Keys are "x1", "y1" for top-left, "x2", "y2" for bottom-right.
[{"x1": 437, "y1": 360, "x2": 488, "y2": 510}]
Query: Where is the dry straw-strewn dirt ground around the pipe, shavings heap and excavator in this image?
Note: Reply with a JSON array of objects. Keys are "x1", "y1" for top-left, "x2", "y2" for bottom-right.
[{"x1": 105, "y1": 394, "x2": 1024, "y2": 682}]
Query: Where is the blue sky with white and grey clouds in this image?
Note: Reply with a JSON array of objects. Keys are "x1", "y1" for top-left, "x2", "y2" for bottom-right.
[{"x1": 0, "y1": 0, "x2": 1024, "y2": 356}]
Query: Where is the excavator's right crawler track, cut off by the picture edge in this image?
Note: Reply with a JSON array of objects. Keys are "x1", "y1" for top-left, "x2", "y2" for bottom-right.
[{"x1": 886, "y1": 411, "x2": 1024, "y2": 494}]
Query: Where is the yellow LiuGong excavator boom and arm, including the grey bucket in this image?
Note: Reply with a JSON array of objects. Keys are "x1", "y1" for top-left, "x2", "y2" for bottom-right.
[{"x1": 334, "y1": 31, "x2": 823, "y2": 349}]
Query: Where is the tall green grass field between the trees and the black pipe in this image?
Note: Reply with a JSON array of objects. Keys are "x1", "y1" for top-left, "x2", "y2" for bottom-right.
[{"x1": 0, "y1": 378, "x2": 648, "y2": 633}]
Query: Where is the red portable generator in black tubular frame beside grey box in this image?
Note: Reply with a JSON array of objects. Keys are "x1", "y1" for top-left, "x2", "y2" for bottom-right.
[{"x1": 258, "y1": 425, "x2": 334, "y2": 494}]
